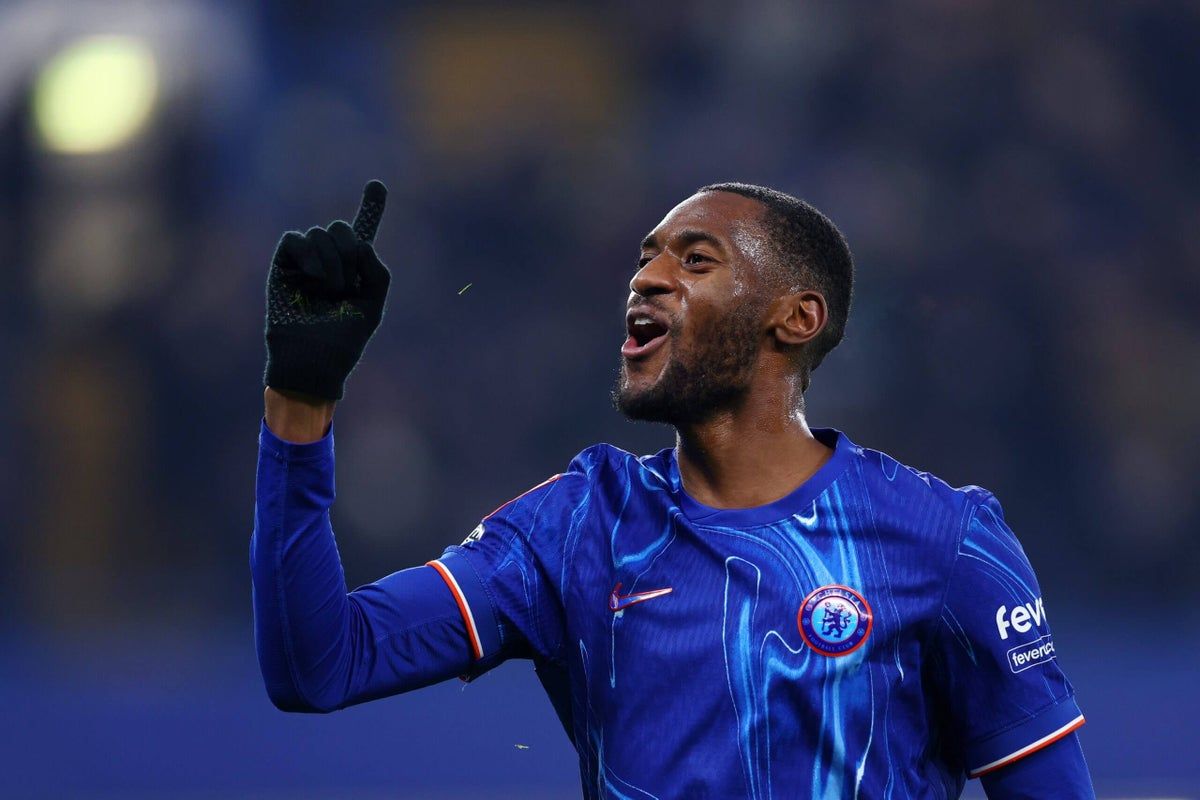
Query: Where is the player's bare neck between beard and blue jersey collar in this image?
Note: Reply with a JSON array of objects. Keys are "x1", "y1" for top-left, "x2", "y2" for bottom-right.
[{"x1": 676, "y1": 374, "x2": 833, "y2": 509}]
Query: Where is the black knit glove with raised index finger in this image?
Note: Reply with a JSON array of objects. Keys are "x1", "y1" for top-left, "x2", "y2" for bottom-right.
[{"x1": 263, "y1": 181, "x2": 391, "y2": 399}]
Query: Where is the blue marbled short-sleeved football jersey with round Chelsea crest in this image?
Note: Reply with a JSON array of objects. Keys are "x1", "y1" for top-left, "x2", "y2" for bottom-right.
[{"x1": 431, "y1": 429, "x2": 1084, "y2": 800}]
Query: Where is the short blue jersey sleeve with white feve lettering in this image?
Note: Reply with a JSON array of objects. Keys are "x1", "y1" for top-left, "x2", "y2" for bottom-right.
[{"x1": 935, "y1": 493, "x2": 1084, "y2": 777}]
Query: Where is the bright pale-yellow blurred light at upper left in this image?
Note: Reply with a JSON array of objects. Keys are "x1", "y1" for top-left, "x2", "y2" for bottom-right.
[{"x1": 34, "y1": 36, "x2": 158, "y2": 154}]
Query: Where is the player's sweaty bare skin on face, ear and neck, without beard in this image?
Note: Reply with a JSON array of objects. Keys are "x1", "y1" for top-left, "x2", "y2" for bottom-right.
[{"x1": 617, "y1": 192, "x2": 832, "y2": 509}]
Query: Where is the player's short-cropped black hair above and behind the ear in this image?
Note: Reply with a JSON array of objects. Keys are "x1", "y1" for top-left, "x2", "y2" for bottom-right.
[{"x1": 696, "y1": 184, "x2": 854, "y2": 386}]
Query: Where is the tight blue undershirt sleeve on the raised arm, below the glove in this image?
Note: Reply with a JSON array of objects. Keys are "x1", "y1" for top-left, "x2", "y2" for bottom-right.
[{"x1": 251, "y1": 429, "x2": 470, "y2": 711}]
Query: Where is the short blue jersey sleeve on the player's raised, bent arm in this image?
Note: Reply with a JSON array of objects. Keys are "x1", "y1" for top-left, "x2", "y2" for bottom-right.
[{"x1": 430, "y1": 451, "x2": 593, "y2": 674}]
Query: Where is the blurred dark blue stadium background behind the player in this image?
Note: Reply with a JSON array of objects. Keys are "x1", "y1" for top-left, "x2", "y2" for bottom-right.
[{"x1": 0, "y1": 0, "x2": 1200, "y2": 799}]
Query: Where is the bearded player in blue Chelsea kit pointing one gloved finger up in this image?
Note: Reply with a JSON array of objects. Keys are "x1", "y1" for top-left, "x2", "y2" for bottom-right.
[{"x1": 251, "y1": 182, "x2": 1093, "y2": 800}]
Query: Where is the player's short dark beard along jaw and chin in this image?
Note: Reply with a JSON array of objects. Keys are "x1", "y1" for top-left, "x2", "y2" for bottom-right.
[{"x1": 612, "y1": 303, "x2": 761, "y2": 427}]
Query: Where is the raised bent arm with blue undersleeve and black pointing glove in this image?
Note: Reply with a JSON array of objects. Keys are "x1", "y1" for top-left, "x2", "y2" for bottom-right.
[{"x1": 250, "y1": 181, "x2": 472, "y2": 712}]
